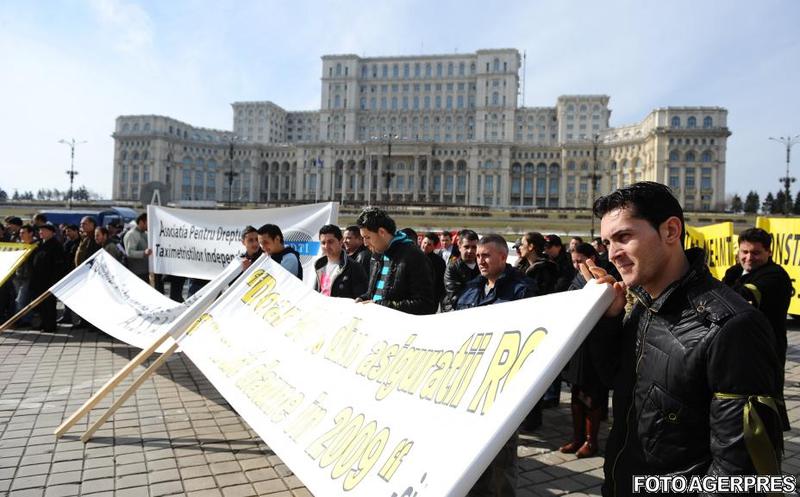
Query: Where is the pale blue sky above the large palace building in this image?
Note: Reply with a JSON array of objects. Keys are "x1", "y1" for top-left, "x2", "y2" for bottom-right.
[{"x1": 0, "y1": 0, "x2": 800, "y2": 202}]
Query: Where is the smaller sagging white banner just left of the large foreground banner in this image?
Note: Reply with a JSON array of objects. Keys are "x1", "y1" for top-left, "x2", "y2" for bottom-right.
[{"x1": 50, "y1": 250, "x2": 242, "y2": 352}]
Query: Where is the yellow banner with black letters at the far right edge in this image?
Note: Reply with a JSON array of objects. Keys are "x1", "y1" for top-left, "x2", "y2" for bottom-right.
[{"x1": 756, "y1": 217, "x2": 800, "y2": 314}]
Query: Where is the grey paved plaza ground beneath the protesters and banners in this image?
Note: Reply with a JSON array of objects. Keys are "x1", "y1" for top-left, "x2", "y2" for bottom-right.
[{"x1": 0, "y1": 320, "x2": 800, "y2": 497}]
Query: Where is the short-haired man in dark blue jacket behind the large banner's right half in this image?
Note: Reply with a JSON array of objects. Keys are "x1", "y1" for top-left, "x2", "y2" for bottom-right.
[{"x1": 456, "y1": 235, "x2": 537, "y2": 497}]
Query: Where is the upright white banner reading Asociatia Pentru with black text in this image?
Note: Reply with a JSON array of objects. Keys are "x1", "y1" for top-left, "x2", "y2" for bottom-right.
[{"x1": 147, "y1": 202, "x2": 339, "y2": 282}]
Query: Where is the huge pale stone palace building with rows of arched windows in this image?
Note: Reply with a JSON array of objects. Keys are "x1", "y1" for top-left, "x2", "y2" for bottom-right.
[{"x1": 113, "y1": 49, "x2": 730, "y2": 211}]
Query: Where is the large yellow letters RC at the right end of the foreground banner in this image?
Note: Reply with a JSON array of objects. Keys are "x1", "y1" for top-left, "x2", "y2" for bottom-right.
[{"x1": 467, "y1": 328, "x2": 547, "y2": 415}]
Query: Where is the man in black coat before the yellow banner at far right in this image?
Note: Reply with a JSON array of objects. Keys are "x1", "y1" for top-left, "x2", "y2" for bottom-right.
[{"x1": 722, "y1": 228, "x2": 794, "y2": 430}]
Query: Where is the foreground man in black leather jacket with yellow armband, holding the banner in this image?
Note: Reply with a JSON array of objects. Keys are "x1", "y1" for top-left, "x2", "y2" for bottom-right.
[{"x1": 581, "y1": 182, "x2": 783, "y2": 496}]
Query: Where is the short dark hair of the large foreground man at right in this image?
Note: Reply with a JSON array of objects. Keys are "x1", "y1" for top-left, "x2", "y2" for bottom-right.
[{"x1": 593, "y1": 181, "x2": 686, "y2": 246}]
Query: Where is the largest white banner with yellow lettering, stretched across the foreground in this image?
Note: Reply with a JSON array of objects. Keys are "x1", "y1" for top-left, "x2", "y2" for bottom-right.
[{"x1": 181, "y1": 254, "x2": 612, "y2": 497}]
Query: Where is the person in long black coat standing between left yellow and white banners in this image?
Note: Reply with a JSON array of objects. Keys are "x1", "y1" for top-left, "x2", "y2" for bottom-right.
[{"x1": 31, "y1": 223, "x2": 65, "y2": 333}]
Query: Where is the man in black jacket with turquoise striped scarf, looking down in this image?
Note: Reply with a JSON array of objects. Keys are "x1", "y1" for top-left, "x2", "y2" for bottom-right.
[{"x1": 356, "y1": 207, "x2": 437, "y2": 314}]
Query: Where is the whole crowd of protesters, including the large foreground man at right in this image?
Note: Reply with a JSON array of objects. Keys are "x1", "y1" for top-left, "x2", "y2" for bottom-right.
[{"x1": 0, "y1": 182, "x2": 793, "y2": 497}]
